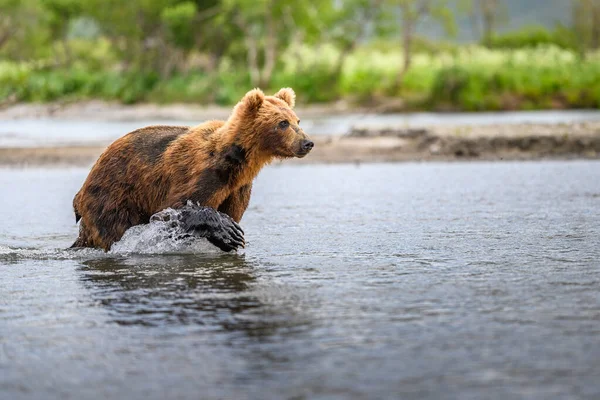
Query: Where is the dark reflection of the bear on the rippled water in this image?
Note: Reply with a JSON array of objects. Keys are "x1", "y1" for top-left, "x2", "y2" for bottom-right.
[{"x1": 79, "y1": 255, "x2": 307, "y2": 338}]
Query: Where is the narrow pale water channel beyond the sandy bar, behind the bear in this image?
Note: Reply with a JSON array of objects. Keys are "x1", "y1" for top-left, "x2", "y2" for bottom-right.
[{"x1": 0, "y1": 110, "x2": 600, "y2": 147}]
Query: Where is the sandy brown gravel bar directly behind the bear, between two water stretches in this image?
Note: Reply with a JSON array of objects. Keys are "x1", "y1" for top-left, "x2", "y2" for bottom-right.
[{"x1": 0, "y1": 122, "x2": 600, "y2": 166}]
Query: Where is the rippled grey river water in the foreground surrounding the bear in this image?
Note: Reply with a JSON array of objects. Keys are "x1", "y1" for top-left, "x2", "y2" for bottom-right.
[{"x1": 0, "y1": 162, "x2": 600, "y2": 399}]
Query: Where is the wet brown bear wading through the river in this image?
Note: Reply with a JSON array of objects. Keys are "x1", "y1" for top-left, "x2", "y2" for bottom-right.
[{"x1": 73, "y1": 88, "x2": 314, "y2": 251}]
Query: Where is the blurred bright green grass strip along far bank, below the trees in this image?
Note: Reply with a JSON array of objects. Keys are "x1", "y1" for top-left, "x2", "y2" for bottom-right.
[{"x1": 0, "y1": 46, "x2": 600, "y2": 111}]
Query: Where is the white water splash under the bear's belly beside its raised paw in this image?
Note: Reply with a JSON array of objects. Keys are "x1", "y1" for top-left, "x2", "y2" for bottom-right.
[{"x1": 109, "y1": 208, "x2": 222, "y2": 254}]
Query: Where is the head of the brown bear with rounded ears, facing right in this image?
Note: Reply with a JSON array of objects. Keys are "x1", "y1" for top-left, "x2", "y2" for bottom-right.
[{"x1": 228, "y1": 88, "x2": 314, "y2": 158}]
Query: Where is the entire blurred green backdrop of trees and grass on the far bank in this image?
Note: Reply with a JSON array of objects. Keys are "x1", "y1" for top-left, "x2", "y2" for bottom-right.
[{"x1": 0, "y1": 0, "x2": 600, "y2": 110}]
